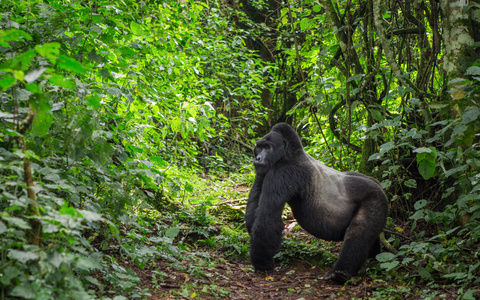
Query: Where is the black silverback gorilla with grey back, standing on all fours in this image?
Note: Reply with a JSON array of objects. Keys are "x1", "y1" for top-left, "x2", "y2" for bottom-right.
[{"x1": 245, "y1": 123, "x2": 388, "y2": 284}]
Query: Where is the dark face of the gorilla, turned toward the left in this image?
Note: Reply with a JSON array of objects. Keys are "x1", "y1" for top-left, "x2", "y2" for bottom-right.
[{"x1": 253, "y1": 132, "x2": 285, "y2": 174}]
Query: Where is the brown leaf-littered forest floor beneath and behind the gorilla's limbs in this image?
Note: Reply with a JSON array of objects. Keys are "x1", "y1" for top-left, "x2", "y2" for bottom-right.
[{"x1": 111, "y1": 182, "x2": 459, "y2": 300}]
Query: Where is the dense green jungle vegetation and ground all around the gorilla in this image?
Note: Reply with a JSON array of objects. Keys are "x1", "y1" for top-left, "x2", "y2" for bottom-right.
[{"x1": 0, "y1": 0, "x2": 480, "y2": 300}]
